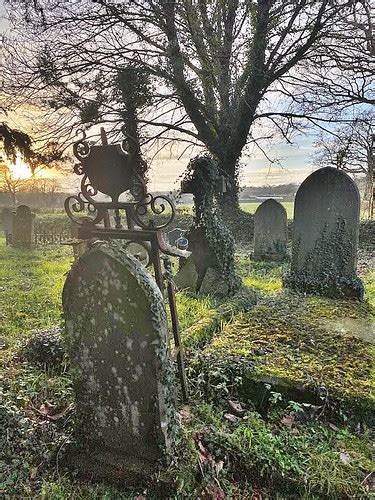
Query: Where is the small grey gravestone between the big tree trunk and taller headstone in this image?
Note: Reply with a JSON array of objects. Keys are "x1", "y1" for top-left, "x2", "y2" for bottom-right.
[{"x1": 253, "y1": 199, "x2": 288, "y2": 261}]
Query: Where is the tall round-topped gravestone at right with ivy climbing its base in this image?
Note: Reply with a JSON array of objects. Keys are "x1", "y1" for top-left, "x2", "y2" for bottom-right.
[{"x1": 285, "y1": 167, "x2": 363, "y2": 299}]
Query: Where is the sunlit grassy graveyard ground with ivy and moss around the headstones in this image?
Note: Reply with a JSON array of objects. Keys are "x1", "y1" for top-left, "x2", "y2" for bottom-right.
[{"x1": 0, "y1": 239, "x2": 375, "y2": 500}]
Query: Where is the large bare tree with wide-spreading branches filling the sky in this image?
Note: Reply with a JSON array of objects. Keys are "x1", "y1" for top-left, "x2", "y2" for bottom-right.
[{"x1": 5, "y1": 0, "x2": 374, "y2": 210}]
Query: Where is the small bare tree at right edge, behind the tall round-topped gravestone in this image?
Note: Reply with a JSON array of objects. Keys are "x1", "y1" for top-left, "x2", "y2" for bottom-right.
[{"x1": 315, "y1": 113, "x2": 375, "y2": 217}]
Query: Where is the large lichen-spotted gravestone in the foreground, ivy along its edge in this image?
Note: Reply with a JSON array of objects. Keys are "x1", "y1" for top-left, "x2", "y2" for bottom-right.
[{"x1": 63, "y1": 242, "x2": 174, "y2": 479}]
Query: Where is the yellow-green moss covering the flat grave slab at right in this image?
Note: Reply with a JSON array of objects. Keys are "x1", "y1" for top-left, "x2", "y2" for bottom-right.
[{"x1": 195, "y1": 293, "x2": 375, "y2": 422}]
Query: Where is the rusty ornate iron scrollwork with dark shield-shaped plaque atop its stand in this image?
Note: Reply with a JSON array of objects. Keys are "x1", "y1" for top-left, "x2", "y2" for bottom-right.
[{"x1": 65, "y1": 129, "x2": 175, "y2": 229}]
